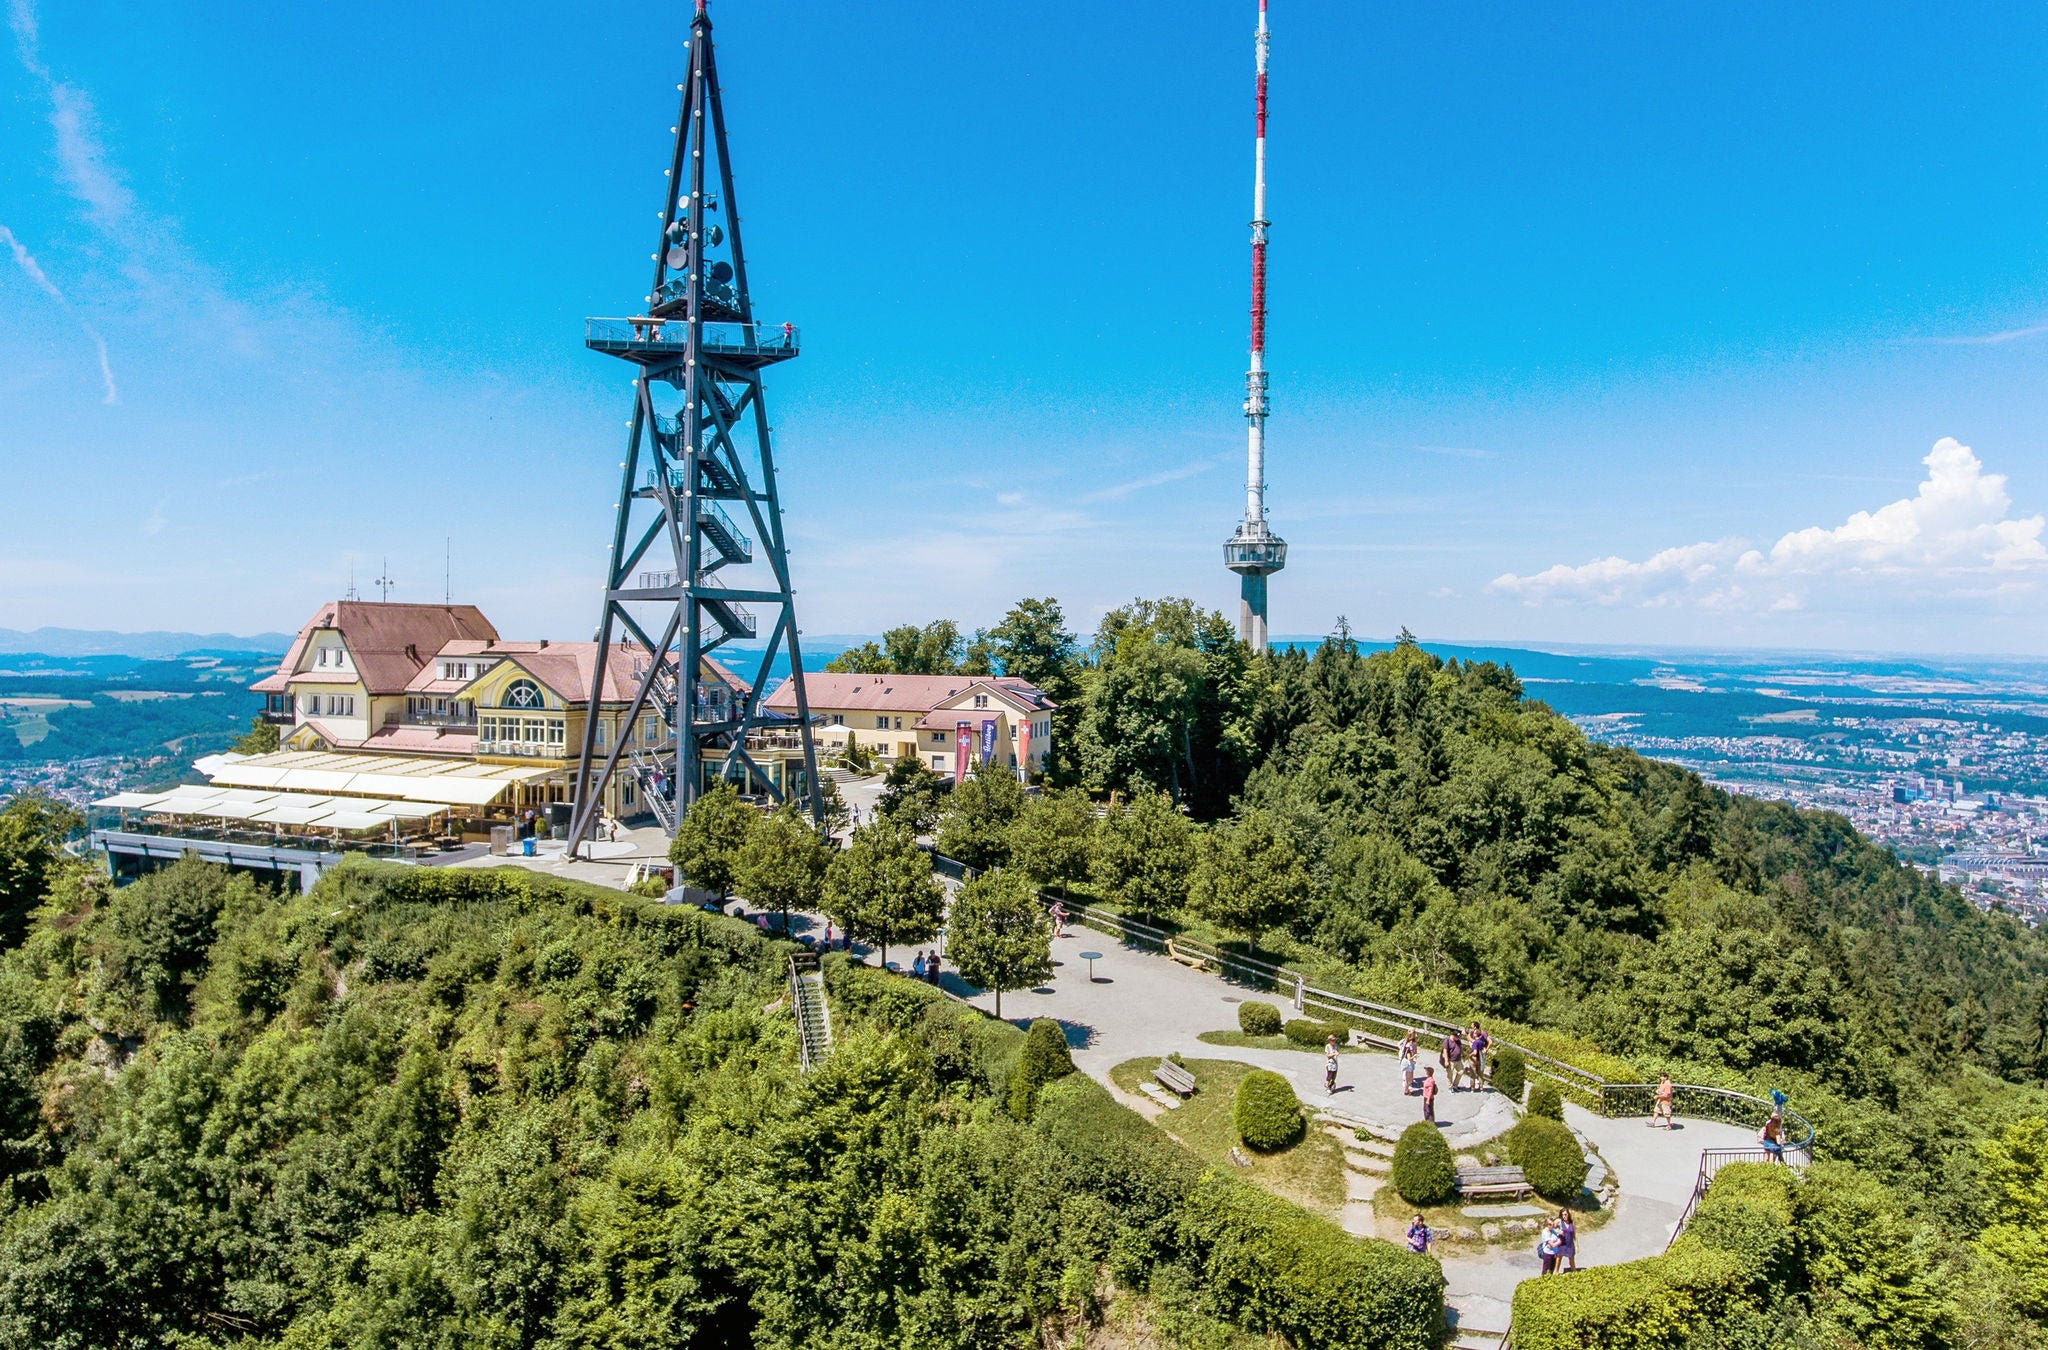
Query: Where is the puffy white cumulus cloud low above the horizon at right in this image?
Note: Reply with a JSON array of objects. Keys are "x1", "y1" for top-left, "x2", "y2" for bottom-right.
[{"x1": 1489, "y1": 436, "x2": 2048, "y2": 613}]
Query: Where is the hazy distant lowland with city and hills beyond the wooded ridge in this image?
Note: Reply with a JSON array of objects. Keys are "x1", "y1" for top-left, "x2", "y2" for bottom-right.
[{"x1": 0, "y1": 633, "x2": 2048, "y2": 922}]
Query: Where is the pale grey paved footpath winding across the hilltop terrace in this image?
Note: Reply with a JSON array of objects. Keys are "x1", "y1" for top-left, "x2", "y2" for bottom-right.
[{"x1": 946, "y1": 926, "x2": 1753, "y2": 1336}]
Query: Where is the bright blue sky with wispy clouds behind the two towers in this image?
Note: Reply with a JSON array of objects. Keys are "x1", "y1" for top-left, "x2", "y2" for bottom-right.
[{"x1": 0, "y1": 0, "x2": 2048, "y2": 653}]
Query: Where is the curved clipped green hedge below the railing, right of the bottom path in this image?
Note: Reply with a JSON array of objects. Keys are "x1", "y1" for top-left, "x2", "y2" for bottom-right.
[{"x1": 1513, "y1": 1163, "x2": 1796, "y2": 1350}]
